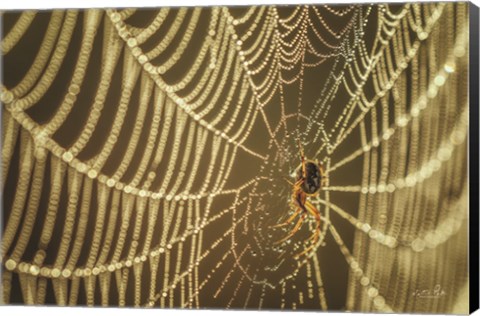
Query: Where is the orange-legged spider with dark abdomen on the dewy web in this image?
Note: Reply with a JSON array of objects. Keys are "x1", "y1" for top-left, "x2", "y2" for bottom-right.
[{"x1": 273, "y1": 141, "x2": 327, "y2": 258}]
